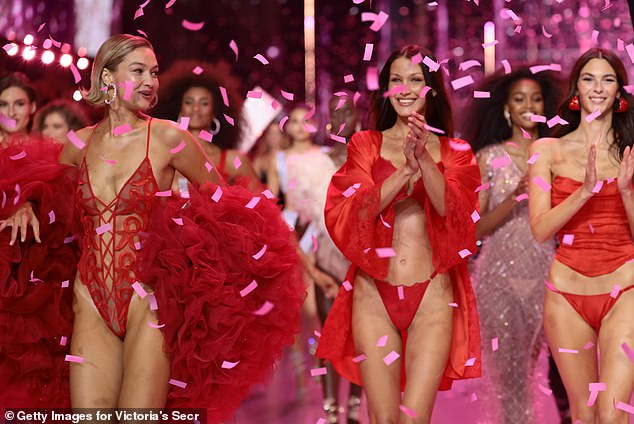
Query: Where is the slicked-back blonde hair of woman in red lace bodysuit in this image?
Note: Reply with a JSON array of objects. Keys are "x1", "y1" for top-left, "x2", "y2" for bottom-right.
[{"x1": 82, "y1": 34, "x2": 154, "y2": 107}]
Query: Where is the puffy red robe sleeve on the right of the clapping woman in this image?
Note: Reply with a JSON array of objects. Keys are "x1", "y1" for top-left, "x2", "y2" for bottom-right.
[{"x1": 424, "y1": 138, "x2": 480, "y2": 273}]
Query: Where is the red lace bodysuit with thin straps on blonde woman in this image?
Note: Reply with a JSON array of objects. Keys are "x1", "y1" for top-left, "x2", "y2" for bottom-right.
[{"x1": 77, "y1": 121, "x2": 158, "y2": 337}]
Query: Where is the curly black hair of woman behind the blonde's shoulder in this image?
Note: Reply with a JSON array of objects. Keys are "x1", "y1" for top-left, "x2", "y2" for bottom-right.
[{"x1": 153, "y1": 60, "x2": 244, "y2": 150}]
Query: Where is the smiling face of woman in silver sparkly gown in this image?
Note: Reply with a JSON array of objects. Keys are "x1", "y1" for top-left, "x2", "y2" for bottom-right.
[{"x1": 504, "y1": 78, "x2": 544, "y2": 130}]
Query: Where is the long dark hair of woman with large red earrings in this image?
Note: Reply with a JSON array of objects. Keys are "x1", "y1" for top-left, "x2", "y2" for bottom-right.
[{"x1": 555, "y1": 47, "x2": 634, "y2": 161}]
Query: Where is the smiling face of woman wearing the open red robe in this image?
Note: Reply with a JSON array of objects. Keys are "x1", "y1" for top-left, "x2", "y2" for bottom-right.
[{"x1": 387, "y1": 57, "x2": 425, "y2": 117}]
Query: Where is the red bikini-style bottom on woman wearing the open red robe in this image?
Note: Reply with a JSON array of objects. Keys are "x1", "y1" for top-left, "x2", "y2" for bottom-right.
[{"x1": 374, "y1": 271, "x2": 437, "y2": 335}]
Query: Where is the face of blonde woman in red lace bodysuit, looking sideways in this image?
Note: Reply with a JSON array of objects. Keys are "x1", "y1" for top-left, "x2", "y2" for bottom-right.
[{"x1": 102, "y1": 47, "x2": 159, "y2": 110}]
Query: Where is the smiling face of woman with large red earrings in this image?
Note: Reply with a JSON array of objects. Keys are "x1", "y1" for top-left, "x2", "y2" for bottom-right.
[{"x1": 577, "y1": 58, "x2": 619, "y2": 115}]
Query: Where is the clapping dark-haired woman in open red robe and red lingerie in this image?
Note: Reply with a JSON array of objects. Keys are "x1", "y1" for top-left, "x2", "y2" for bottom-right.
[{"x1": 317, "y1": 45, "x2": 480, "y2": 423}]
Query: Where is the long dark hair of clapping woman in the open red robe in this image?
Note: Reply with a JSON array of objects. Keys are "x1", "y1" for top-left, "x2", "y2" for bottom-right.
[{"x1": 370, "y1": 44, "x2": 453, "y2": 137}]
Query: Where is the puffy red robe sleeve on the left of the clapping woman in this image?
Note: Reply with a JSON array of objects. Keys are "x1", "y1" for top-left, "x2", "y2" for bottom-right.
[{"x1": 325, "y1": 131, "x2": 391, "y2": 279}]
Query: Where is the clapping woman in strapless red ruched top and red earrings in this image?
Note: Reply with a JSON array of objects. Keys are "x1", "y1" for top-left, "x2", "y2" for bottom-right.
[{"x1": 529, "y1": 48, "x2": 634, "y2": 423}]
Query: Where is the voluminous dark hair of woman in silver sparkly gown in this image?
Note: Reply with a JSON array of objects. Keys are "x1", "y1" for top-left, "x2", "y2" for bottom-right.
[{"x1": 462, "y1": 67, "x2": 562, "y2": 152}]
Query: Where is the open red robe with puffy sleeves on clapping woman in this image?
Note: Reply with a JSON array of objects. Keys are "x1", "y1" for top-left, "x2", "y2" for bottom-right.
[{"x1": 316, "y1": 131, "x2": 481, "y2": 390}]
